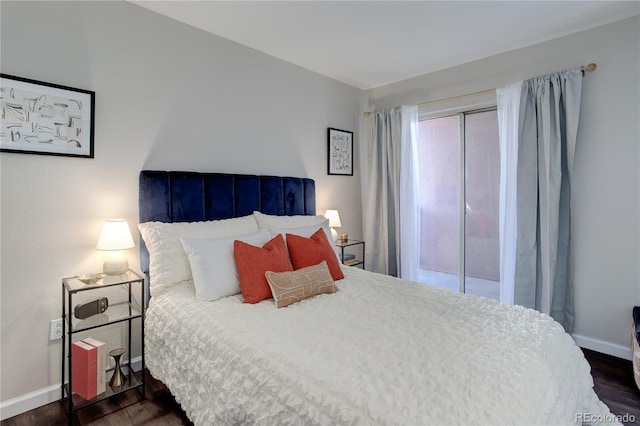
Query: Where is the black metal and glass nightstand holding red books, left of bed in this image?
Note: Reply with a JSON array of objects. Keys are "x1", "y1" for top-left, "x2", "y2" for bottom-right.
[{"x1": 61, "y1": 270, "x2": 146, "y2": 424}]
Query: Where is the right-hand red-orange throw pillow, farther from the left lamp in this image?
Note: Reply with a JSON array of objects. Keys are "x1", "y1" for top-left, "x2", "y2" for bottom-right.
[{"x1": 287, "y1": 228, "x2": 344, "y2": 281}]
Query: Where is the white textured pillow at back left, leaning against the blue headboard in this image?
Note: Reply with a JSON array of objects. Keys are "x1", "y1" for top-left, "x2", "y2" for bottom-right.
[{"x1": 138, "y1": 215, "x2": 259, "y2": 289}]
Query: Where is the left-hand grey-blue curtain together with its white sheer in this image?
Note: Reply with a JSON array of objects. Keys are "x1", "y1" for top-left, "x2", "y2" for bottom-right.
[{"x1": 363, "y1": 105, "x2": 419, "y2": 280}]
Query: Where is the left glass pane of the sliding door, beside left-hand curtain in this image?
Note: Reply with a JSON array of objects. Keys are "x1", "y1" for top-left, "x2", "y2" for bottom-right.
[{"x1": 418, "y1": 116, "x2": 460, "y2": 291}]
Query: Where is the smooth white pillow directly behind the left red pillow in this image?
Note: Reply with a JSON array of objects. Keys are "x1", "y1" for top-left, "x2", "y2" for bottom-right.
[{"x1": 180, "y1": 229, "x2": 271, "y2": 302}]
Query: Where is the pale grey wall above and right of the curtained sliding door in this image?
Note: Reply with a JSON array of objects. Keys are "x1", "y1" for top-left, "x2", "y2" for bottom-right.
[{"x1": 363, "y1": 17, "x2": 640, "y2": 359}]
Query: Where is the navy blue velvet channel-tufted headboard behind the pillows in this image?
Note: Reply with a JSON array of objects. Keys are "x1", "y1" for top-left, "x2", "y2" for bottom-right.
[{"x1": 139, "y1": 170, "x2": 316, "y2": 274}]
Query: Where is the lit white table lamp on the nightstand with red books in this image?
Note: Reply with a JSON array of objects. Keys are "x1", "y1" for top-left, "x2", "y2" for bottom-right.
[{"x1": 96, "y1": 219, "x2": 135, "y2": 275}]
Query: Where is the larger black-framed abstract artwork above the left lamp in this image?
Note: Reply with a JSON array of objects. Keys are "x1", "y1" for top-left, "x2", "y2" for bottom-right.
[{"x1": 0, "y1": 74, "x2": 95, "y2": 158}]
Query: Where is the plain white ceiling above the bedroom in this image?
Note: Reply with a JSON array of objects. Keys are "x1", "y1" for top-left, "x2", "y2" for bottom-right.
[{"x1": 132, "y1": 0, "x2": 640, "y2": 89}]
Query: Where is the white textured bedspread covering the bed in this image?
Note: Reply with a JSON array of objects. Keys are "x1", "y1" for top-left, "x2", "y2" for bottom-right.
[{"x1": 145, "y1": 268, "x2": 611, "y2": 425}]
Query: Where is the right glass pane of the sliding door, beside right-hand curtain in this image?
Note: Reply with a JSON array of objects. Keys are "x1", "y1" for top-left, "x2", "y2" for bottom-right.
[{"x1": 465, "y1": 110, "x2": 500, "y2": 300}]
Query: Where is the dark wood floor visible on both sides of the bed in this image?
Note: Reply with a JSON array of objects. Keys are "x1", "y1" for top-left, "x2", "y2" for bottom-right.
[{"x1": 1, "y1": 349, "x2": 640, "y2": 426}]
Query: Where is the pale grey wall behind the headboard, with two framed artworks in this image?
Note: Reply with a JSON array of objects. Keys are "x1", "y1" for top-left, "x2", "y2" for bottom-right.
[{"x1": 0, "y1": 1, "x2": 362, "y2": 412}]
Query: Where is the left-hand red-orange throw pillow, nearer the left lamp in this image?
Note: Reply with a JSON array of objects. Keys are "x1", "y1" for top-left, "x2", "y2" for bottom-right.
[{"x1": 233, "y1": 234, "x2": 293, "y2": 303}]
